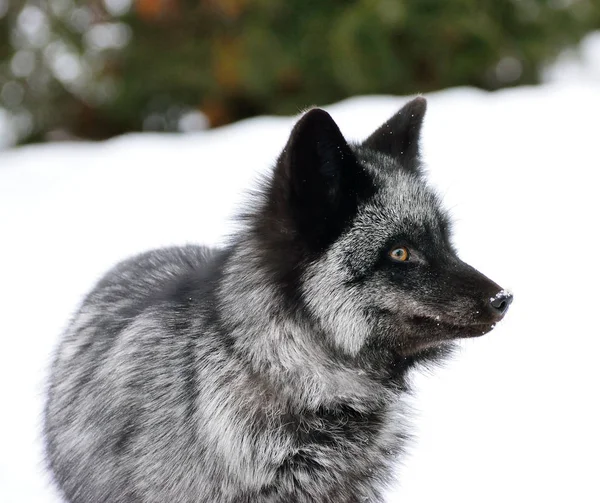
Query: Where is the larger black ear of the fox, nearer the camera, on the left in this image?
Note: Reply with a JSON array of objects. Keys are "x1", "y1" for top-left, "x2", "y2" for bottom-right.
[{"x1": 273, "y1": 108, "x2": 373, "y2": 251}]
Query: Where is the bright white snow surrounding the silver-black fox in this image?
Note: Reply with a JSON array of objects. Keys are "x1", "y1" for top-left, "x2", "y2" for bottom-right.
[{"x1": 0, "y1": 34, "x2": 600, "y2": 503}]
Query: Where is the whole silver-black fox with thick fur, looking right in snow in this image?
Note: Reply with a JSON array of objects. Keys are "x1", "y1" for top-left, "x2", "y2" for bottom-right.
[{"x1": 43, "y1": 97, "x2": 513, "y2": 503}]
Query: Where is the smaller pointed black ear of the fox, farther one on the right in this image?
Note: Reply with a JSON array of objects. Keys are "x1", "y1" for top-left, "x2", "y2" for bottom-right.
[{"x1": 363, "y1": 97, "x2": 427, "y2": 172}]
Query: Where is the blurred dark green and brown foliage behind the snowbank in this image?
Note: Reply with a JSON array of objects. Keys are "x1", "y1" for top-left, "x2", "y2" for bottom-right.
[{"x1": 0, "y1": 0, "x2": 600, "y2": 147}]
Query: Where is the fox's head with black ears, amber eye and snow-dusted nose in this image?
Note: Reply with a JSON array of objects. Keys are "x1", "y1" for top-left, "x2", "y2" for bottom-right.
[{"x1": 255, "y1": 98, "x2": 512, "y2": 357}]
